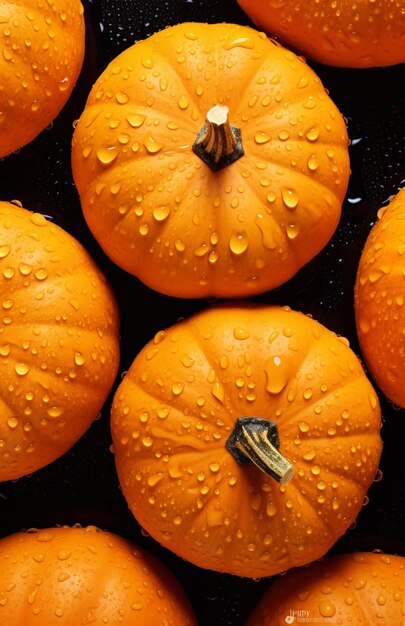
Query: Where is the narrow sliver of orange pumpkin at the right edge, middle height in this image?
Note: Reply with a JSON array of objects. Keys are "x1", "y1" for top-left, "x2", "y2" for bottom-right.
[{"x1": 355, "y1": 189, "x2": 405, "y2": 407}]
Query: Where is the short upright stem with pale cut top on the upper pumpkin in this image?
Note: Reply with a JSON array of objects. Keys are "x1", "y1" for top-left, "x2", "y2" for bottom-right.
[{"x1": 193, "y1": 104, "x2": 244, "y2": 172}]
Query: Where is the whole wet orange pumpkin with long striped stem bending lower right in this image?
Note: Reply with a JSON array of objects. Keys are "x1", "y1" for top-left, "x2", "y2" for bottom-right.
[{"x1": 111, "y1": 304, "x2": 381, "y2": 577}]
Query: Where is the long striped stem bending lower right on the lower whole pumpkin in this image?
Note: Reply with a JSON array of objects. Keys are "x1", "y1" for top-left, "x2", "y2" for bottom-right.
[{"x1": 225, "y1": 417, "x2": 294, "y2": 485}]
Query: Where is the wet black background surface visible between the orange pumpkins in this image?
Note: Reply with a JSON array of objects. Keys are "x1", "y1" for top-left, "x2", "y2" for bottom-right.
[{"x1": 0, "y1": 0, "x2": 405, "y2": 626}]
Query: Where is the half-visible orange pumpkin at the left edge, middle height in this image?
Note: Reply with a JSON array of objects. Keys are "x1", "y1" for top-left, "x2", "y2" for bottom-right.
[{"x1": 0, "y1": 202, "x2": 119, "y2": 480}]
